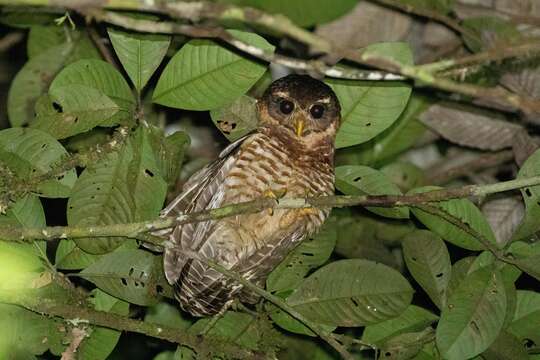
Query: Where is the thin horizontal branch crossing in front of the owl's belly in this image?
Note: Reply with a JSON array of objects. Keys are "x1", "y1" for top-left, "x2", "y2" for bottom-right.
[{"x1": 0, "y1": 176, "x2": 540, "y2": 245}]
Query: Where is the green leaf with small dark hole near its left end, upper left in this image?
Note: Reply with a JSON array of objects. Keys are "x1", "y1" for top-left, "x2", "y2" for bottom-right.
[{"x1": 31, "y1": 85, "x2": 120, "y2": 139}]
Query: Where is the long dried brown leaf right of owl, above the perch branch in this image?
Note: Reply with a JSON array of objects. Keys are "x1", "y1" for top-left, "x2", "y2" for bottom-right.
[{"x1": 420, "y1": 104, "x2": 522, "y2": 151}]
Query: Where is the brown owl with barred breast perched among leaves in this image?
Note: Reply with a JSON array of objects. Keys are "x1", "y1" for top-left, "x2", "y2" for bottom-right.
[{"x1": 162, "y1": 75, "x2": 340, "y2": 316}]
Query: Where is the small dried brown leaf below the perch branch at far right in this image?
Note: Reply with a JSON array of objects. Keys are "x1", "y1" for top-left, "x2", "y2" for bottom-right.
[{"x1": 482, "y1": 197, "x2": 525, "y2": 245}]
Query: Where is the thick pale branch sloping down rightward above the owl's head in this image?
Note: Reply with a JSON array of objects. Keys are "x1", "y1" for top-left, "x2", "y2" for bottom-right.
[{"x1": 0, "y1": 0, "x2": 540, "y2": 112}]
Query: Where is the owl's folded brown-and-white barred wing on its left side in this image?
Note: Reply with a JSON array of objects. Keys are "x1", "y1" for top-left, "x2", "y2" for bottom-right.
[{"x1": 161, "y1": 134, "x2": 250, "y2": 284}]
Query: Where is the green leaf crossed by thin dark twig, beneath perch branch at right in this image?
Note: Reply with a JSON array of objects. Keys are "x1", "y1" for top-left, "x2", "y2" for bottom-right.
[{"x1": 409, "y1": 186, "x2": 497, "y2": 250}]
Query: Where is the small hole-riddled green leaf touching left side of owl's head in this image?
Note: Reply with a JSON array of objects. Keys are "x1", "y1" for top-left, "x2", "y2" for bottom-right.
[{"x1": 210, "y1": 95, "x2": 258, "y2": 142}]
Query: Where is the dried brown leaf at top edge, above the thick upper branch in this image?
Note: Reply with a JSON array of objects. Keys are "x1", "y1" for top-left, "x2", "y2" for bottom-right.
[{"x1": 315, "y1": 1, "x2": 412, "y2": 49}]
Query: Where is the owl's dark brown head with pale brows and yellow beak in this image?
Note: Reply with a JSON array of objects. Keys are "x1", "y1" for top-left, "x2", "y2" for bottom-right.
[{"x1": 257, "y1": 75, "x2": 341, "y2": 140}]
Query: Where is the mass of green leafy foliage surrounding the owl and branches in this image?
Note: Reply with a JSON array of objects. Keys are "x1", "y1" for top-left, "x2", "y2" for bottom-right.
[{"x1": 0, "y1": 0, "x2": 540, "y2": 360}]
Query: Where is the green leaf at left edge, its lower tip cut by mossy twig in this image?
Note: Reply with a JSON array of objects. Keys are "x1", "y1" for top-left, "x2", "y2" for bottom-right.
[{"x1": 0, "y1": 128, "x2": 77, "y2": 198}]
